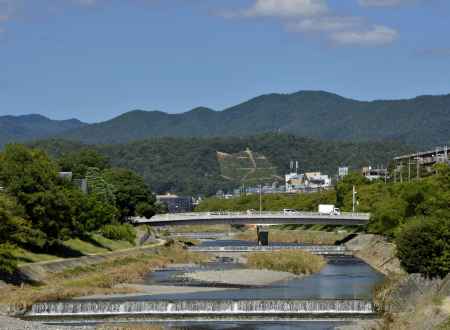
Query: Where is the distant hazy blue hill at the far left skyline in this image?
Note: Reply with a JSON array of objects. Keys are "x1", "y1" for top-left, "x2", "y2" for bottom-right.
[{"x1": 0, "y1": 115, "x2": 86, "y2": 148}]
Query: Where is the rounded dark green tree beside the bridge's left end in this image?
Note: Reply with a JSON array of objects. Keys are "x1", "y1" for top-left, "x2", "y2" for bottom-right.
[{"x1": 103, "y1": 168, "x2": 156, "y2": 220}]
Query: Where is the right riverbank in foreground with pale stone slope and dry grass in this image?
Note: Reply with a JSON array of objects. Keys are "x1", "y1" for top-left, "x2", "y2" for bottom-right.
[{"x1": 340, "y1": 234, "x2": 450, "y2": 330}]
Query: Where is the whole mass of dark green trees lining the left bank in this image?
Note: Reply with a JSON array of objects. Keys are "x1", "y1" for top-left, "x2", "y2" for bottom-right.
[{"x1": 0, "y1": 144, "x2": 158, "y2": 273}]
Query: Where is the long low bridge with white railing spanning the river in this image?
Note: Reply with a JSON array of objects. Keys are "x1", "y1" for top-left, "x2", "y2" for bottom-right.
[{"x1": 130, "y1": 212, "x2": 370, "y2": 226}]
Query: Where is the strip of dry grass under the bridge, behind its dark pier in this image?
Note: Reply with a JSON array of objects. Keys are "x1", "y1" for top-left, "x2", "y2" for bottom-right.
[{"x1": 236, "y1": 229, "x2": 348, "y2": 245}]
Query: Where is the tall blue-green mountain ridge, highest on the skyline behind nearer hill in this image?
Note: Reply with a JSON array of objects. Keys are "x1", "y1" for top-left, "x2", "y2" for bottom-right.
[{"x1": 57, "y1": 91, "x2": 450, "y2": 148}]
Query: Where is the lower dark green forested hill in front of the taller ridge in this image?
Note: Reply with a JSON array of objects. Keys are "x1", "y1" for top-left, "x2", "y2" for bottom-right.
[{"x1": 34, "y1": 134, "x2": 410, "y2": 195}]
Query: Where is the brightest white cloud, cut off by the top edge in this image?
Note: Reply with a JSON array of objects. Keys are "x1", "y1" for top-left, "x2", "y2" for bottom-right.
[{"x1": 221, "y1": 0, "x2": 329, "y2": 18}]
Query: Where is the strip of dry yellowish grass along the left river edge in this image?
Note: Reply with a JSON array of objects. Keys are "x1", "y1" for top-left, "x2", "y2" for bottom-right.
[{"x1": 0, "y1": 244, "x2": 207, "y2": 309}]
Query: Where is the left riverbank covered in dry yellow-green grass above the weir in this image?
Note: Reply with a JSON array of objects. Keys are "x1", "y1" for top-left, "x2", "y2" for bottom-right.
[{"x1": 0, "y1": 242, "x2": 207, "y2": 314}]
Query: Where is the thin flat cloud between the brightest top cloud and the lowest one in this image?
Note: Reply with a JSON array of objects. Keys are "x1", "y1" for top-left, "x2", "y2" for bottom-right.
[{"x1": 286, "y1": 16, "x2": 363, "y2": 33}]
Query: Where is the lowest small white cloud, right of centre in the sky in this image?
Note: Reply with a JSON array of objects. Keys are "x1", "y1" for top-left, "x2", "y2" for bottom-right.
[{"x1": 330, "y1": 25, "x2": 399, "y2": 47}]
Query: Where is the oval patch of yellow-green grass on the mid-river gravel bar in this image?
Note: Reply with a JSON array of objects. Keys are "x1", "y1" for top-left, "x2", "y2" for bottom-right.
[{"x1": 247, "y1": 250, "x2": 326, "y2": 275}]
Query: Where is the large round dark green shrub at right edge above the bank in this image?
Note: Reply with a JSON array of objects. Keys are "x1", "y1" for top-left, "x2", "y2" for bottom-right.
[{"x1": 396, "y1": 218, "x2": 450, "y2": 278}]
